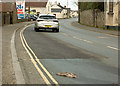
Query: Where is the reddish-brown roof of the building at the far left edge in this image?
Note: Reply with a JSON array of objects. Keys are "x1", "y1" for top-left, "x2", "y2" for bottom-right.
[{"x1": 0, "y1": 3, "x2": 16, "y2": 12}]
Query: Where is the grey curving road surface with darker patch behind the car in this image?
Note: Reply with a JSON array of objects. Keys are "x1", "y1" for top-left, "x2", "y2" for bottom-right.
[{"x1": 19, "y1": 18, "x2": 119, "y2": 84}]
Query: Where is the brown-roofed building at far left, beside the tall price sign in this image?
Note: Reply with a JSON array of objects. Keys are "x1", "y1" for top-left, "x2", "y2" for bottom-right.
[{"x1": 0, "y1": 2, "x2": 17, "y2": 25}]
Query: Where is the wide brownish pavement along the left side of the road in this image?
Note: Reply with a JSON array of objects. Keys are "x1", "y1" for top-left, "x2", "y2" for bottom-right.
[{"x1": 2, "y1": 22, "x2": 31, "y2": 84}]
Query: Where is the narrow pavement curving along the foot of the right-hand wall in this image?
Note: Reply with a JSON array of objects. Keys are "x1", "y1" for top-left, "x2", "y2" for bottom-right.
[{"x1": 71, "y1": 21, "x2": 120, "y2": 36}]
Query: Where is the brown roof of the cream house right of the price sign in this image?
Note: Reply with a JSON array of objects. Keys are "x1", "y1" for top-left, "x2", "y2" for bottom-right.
[{"x1": 25, "y1": 2, "x2": 47, "y2": 7}]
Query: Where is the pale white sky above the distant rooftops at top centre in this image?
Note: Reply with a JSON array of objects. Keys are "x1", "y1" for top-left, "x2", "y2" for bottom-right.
[{"x1": 49, "y1": 0, "x2": 78, "y2": 10}]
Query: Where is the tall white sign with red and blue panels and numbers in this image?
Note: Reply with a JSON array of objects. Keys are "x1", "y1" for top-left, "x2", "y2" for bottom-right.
[{"x1": 16, "y1": 0, "x2": 25, "y2": 19}]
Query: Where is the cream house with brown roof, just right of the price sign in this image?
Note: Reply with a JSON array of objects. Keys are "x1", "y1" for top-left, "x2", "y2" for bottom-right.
[{"x1": 25, "y1": 1, "x2": 47, "y2": 15}]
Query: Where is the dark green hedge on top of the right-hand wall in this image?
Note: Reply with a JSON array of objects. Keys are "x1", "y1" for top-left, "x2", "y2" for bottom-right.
[{"x1": 79, "y1": 2, "x2": 104, "y2": 11}]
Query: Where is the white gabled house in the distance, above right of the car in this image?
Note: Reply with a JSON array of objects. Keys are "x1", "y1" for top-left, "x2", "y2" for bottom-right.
[{"x1": 46, "y1": 1, "x2": 70, "y2": 18}]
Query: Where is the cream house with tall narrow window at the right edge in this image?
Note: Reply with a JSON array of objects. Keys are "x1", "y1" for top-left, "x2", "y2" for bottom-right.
[{"x1": 105, "y1": 0, "x2": 120, "y2": 30}]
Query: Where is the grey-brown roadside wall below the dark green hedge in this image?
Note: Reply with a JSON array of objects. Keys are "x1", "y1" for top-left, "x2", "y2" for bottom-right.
[{"x1": 80, "y1": 9, "x2": 104, "y2": 27}]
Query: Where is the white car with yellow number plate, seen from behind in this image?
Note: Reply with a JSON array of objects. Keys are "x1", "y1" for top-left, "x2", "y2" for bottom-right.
[{"x1": 34, "y1": 14, "x2": 59, "y2": 32}]
